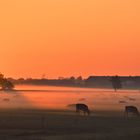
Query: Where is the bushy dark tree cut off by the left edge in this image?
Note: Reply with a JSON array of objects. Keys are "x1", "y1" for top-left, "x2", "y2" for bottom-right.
[{"x1": 0, "y1": 74, "x2": 14, "y2": 90}]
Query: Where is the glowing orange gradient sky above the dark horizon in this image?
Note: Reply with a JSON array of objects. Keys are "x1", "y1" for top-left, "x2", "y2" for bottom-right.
[{"x1": 0, "y1": 0, "x2": 140, "y2": 78}]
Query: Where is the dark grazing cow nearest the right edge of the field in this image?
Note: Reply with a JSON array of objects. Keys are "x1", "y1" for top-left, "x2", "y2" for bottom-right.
[{"x1": 125, "y1": 106, "x2": 139, "y2": 117}]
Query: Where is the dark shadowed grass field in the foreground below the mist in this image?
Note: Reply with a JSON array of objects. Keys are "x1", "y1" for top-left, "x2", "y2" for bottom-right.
[{"x1": 0, "y1": 109, "x2": 140, "y2": 140}]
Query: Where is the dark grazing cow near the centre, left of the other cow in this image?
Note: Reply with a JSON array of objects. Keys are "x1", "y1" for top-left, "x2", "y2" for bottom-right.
[{"x1": 76, "y1": 104, "x2": 90, "y2": 115}]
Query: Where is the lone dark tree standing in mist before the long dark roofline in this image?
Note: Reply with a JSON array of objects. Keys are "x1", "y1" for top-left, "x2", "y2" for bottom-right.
[{"x1": 111, "y1": 75, "x2": 122, "y2": 92}]
